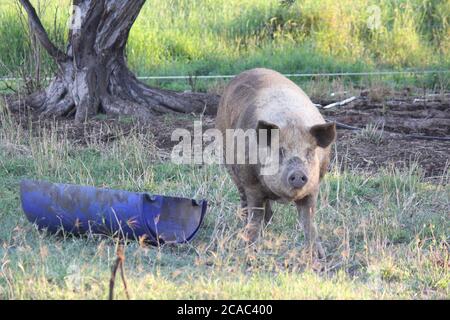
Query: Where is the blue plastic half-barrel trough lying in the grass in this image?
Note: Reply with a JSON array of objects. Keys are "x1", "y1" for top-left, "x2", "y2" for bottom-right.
[{"x1": 20, "y1": 180, "x2": 207, "y2": 244}]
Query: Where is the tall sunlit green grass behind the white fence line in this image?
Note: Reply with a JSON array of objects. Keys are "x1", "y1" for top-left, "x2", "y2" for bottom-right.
[{"x1": 0, "y1": 0, "x2": 450, "y2": 89}]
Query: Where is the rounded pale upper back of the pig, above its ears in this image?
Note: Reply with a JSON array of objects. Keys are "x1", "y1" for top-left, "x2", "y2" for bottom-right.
[{"x1": 216, "y1": 68, "x2": 325, "y2": 132}]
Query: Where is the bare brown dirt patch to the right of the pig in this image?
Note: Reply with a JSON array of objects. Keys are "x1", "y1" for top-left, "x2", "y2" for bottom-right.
[{"x1": 321, "y1": 93, "x2": 450, "y2": 178}]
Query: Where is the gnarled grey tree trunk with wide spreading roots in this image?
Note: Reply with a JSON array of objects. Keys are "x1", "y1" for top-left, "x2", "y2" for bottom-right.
[{"x1": 13, "y1": 0, "x2": 218, "y2": 122}]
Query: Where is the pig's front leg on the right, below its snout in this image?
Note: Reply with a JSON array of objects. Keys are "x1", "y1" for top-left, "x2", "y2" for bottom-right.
[{"x1": 296, "y1": 192, "x2": 325, "y2": 259}]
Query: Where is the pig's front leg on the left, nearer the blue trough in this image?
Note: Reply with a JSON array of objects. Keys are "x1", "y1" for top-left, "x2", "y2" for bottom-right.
[{"x1": 245, "y1": 190, "x2": 266, "y2": 244}]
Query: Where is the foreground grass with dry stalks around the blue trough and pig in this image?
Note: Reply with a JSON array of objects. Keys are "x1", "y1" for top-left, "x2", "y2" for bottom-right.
[{"x1": 0, "y1": 105, "x2": 450, "y2": 299}]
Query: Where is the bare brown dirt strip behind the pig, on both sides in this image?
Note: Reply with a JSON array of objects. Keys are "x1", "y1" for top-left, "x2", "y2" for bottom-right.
[{"x1": 4, "y1": 94, "x2": 450, "y2": 180}]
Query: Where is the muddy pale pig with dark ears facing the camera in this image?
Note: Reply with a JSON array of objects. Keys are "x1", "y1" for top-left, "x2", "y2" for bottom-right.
[{"x1": 216, "y1": 68, "x2": 336, "y2": 258}]
